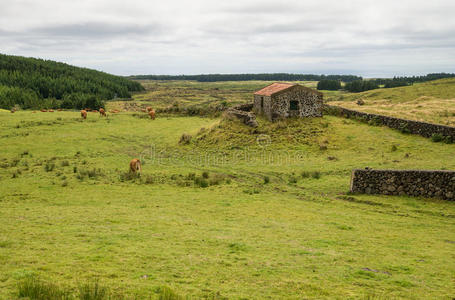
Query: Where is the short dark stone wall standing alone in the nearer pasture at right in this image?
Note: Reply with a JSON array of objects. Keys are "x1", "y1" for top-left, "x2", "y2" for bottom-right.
[{"x1": 351, "y1": 169, "x2": 455, "y2": 200}]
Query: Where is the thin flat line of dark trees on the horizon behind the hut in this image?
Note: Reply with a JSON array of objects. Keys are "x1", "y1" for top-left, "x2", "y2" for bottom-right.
[{"x1": 128, "y1": 73, "x2": 362, "y2": 82}]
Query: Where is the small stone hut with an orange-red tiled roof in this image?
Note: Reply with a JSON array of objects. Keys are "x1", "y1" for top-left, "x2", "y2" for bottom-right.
[{"x1": 253, "y1": 82, "x2": 322, "y2": 121}]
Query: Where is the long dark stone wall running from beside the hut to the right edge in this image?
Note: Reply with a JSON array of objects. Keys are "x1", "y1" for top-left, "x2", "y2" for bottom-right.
[{"x1": 324, "y1": 104, "x2": 455, "y2": 142}]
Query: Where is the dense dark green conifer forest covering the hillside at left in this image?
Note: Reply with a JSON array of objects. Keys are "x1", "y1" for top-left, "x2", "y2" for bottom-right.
[{"x1": 0, "y1": 54, "x2": 144, "y2": 109}]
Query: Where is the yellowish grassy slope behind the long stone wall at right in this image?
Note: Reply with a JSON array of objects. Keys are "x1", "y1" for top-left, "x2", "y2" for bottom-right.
[{"x1": 324, "y1": 78, "x2": 455, "y2": 126}]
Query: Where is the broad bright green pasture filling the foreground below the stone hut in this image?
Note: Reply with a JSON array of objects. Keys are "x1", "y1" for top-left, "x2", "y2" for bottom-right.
[{"x1": 0, "y1": 82, "x2": 455, "y2": 299}]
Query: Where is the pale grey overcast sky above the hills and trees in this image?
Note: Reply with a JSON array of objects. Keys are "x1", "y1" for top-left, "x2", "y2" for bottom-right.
[{"x1": 0, "y1": 0, "x2": 455, "y2": 77}]
